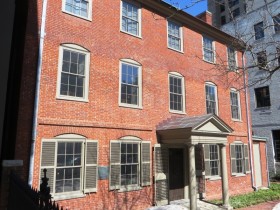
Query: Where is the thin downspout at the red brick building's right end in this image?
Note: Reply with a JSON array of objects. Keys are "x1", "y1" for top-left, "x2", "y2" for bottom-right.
[{"x1": 242, "y1": 52, "x2": 257, "y2": 191}]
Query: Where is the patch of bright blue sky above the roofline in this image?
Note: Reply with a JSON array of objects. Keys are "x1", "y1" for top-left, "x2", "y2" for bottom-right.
[{"x1": 164, "y1": 0, "x2": 207, "y2": 16}]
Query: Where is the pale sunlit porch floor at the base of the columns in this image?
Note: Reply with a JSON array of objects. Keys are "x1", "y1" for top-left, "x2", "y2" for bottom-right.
[{"x1": 147, "y1": 199, "x2": 223, "y2": 210}]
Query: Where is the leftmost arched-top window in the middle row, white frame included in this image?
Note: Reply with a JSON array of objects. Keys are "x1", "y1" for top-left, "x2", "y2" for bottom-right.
[{"x1": 57, "y1": 44, "x2": 89, "y2": 101}]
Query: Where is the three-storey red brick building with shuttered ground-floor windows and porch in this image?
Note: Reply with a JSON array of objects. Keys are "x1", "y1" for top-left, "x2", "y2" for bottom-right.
[{"x1": 2, "y1": 0, "x2": 268, "y2": 209}]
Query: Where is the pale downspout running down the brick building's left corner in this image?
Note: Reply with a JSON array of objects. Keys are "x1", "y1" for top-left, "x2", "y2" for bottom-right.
[{"x1": 28, "y1": 0, "x2": 48, "y2": 186}]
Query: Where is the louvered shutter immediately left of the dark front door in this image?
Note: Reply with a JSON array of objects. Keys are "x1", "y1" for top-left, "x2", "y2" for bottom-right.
[{"x1": 154, "y1": 144, "x2": 169, "y2": 206}]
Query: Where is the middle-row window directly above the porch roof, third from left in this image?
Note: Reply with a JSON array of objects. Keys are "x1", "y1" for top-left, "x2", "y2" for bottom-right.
[{"x1": 169, "y1": 72, "x2": 185, "y2": 112}]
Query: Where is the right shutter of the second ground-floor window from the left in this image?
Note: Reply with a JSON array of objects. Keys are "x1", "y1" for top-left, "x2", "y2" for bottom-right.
[{"x1": 141, "y1": 141, "x2": 151, "y2": 186}]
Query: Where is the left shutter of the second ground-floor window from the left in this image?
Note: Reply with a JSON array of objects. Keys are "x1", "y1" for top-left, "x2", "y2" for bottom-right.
[{"x1": 109, "y1": 140, "x2": 121, "y2": 190}]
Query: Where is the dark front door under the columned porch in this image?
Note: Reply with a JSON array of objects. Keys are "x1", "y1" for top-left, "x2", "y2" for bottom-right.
[{"x1": 169, "y1": 148, "x2": 184, "y2": 202}]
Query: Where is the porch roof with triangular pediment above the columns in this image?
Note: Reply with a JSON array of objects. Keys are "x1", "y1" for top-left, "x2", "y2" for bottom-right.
[{"x1": 156, "y1": 114, "x2": 233, "y2": 144}]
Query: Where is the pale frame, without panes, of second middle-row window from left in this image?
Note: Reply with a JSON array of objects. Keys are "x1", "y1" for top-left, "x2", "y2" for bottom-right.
[{"x1": 119, "y1": 59, "x2": 143, "y2": 109}]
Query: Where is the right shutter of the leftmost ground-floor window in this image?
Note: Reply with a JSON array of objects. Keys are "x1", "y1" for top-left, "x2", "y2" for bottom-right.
[{"x1": 84, "y1": 139, "x2": 98, "y2": 193}]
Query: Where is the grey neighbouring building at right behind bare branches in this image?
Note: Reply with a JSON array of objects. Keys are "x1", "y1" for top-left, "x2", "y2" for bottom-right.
[{"x1": 209, "y1": 0, "x2": 280, "y2": 176}]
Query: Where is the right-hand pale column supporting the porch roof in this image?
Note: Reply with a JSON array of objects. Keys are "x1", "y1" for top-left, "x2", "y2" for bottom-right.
[{"x1": 220, "y1": 144, "x2": 232, "y2": 209}]
